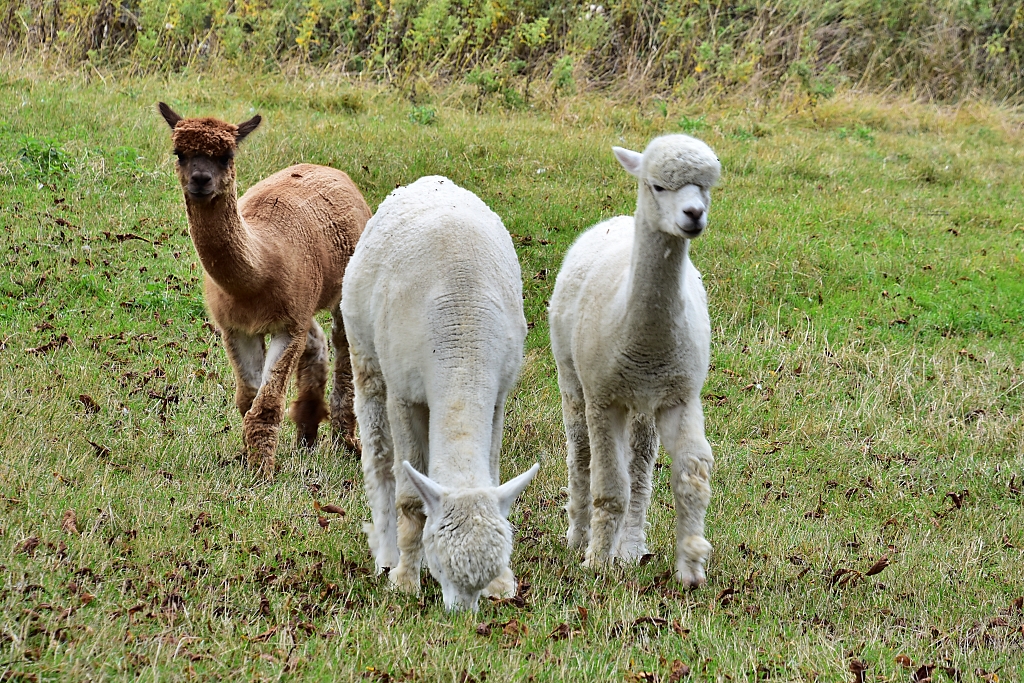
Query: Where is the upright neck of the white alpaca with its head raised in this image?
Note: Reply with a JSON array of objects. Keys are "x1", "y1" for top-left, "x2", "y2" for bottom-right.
[{"x1": 625, "y1": 200, "x2": 690, "y2": 343}]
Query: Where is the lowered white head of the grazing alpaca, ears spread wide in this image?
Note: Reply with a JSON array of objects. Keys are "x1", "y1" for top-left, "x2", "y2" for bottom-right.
[{"x1": 402, "y1": 462, "x2": 541, "y2": 611}]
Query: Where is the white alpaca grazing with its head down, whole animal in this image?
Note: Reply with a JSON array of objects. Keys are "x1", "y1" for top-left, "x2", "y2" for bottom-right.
[{"x1": 341, "y1": 176, "x2": 540, "y2": 610}]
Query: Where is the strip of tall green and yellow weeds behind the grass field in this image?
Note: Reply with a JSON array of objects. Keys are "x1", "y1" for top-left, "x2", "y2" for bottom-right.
[{"x1": 6, "y1": 0, "x2": 1024, "y2": 100}]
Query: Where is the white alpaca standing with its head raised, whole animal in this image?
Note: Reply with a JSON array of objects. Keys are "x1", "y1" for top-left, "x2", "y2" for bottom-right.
[{"x1": 552, "y1": 135, "x2": 721, "y2": 587}]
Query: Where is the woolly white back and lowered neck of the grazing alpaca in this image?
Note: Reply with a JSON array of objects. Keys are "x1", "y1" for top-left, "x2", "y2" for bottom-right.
[{"x1": 342, "y1": 176, "x2": 526, "y2": 485}]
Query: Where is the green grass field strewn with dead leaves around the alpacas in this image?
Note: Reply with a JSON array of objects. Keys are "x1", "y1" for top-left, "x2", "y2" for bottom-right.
[{"x1": 0, "y1": 62, "x2": 1024, "y2": 683}]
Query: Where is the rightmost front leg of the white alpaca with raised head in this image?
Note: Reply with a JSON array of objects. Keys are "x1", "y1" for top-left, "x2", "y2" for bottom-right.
[{"x1": 657, "y1": 398, "x2": 715, "y2": 588}]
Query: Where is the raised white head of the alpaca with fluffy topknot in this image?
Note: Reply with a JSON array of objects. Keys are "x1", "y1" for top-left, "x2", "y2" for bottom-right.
[{"x1": 611, "y1": 135, "x2": 722, "y2": 240}]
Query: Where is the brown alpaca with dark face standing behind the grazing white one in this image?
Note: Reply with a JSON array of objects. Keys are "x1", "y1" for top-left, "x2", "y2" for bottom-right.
[{"x1": 160, "y1": 102, "x2": 372, "y2": 478}]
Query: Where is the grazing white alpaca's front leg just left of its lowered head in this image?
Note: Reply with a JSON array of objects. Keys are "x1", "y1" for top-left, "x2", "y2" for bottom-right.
[{"x1": 388, "y1": 399, "x2": 430, "y2": 594}]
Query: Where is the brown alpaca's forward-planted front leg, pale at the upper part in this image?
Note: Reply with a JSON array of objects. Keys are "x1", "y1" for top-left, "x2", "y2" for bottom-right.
[{"x1": 242, "y1": 330, "x2": 306, "y2": 479}]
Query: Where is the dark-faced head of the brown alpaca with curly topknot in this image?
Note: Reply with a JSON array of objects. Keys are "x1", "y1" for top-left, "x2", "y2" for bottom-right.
[{"x1": 160, "y1": 102, "x2": 262, "y2": 204}]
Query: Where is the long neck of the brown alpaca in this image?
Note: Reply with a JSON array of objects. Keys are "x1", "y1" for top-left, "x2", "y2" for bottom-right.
[{"x1": 185, "y1": 188, "x2": 264, "y2": 295}]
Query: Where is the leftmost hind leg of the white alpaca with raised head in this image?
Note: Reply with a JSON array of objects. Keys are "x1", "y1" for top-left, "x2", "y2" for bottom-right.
[{"x1": 558, "y1": 372, "x2": 591, "y2": 548}]
